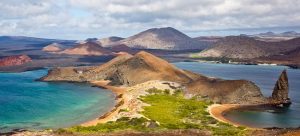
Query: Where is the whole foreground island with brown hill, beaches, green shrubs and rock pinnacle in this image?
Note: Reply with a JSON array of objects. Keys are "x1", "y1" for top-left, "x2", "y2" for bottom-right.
[{"x1": 9, "y1": 51, "x2": 297, "y2": 135}]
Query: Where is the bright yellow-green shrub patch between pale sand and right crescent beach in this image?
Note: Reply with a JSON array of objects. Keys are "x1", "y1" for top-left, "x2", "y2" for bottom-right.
[{"x1": 141, "y1": 92, "x2": 247, "y2": 136}]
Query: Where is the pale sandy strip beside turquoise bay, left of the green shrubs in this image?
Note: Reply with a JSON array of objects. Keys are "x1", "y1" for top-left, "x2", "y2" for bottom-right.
[{"x1": 81, "y1": 80, "x2": 181, "y2": 126}]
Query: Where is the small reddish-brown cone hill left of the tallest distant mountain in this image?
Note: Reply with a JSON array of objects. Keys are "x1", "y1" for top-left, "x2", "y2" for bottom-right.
[{"x1": 60, "y1": 42, "x2": 111, "y2": 56}]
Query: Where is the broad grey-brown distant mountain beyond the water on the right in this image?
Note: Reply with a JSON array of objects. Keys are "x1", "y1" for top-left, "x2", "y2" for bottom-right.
[{"x1": 198, "y1": 36, "x2": 300, "y2": 59}]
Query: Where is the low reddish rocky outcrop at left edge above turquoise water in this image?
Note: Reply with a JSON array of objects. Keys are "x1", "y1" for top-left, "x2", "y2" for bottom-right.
[{"x1": 0, "y1": 55, "x2": 32, "y2": 66}]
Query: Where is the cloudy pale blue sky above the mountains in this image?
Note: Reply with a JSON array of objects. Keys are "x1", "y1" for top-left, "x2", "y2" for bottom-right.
[{"x1": 0, "y1": 0, "x2": 300, "y2": 40}]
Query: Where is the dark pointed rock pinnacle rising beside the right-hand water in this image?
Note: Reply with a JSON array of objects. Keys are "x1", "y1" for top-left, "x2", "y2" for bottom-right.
[{"x1": 271, "y1": 70, "x2": 291, "y2": 104}]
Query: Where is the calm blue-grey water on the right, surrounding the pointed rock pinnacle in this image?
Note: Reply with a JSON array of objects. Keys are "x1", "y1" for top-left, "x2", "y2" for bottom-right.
[{"x1": 175, "y1": 62, "x2": 300, "y2": 127}]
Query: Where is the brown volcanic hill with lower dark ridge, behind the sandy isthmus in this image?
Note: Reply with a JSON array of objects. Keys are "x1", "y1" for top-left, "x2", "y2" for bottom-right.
[{"x1": 41, "y1": 51, "x2": 288, "y2": 104}]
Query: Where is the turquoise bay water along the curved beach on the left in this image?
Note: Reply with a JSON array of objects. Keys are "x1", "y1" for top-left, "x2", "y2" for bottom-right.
[{"x1": 0, "y1": 70, "x2": 114, "y2": 132}]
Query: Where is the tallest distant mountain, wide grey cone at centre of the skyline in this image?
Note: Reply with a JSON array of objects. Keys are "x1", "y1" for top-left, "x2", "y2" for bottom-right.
[{"x1": 116, "y1": 27, "x2": 208, "y2": 50}]
